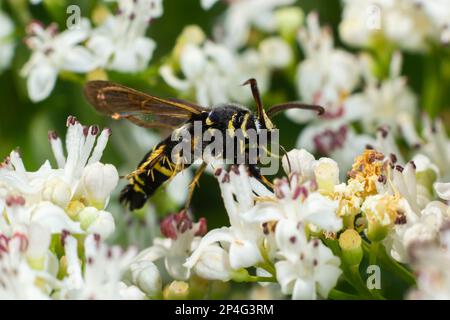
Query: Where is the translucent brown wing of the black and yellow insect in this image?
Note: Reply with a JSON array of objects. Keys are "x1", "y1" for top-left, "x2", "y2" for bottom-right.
[{"x1": 84, "y1": 81, "x2": 207, "y2": 129}]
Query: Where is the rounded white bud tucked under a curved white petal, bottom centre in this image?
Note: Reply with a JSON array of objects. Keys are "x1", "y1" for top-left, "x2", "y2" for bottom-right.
[{"x1": 194, "y1": 245, "x2": 233, "y2": 281}]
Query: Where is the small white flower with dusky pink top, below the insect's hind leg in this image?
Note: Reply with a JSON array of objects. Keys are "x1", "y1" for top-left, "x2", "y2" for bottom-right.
[{"x1": 136, "y1": 211, "x2": 206, "y2": 280}]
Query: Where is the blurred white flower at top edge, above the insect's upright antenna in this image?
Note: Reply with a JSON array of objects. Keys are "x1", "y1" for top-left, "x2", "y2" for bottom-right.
[{"x1": 201, "y1": 0, "x2": 294, "y2": 48}]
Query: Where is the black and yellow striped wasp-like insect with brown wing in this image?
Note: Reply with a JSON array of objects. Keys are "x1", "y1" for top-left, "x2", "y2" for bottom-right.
[{"x1": 84, "y1": 79, "x2": 324, "y2": 210}]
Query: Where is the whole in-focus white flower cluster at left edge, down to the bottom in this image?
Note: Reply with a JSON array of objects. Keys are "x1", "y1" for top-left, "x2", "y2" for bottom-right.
[{"x1": 0, "y1": 116, "x2": 143, "y2": 299}]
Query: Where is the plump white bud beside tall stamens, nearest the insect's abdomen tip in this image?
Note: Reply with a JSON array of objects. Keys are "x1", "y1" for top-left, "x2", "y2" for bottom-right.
[{"x1": 81, "y1": 162, "x2": 119, "y2": 210}]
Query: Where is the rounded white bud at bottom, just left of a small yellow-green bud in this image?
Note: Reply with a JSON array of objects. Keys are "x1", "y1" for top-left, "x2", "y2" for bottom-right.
[{"x1": 130, "y1": 260, "x2": 162, "y2": 297}]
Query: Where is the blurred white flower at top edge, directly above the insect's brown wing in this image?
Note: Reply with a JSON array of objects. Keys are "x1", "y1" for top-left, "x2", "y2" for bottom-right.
[{"x1": 87, "y1": 0, "x2": 163, "y2": 72}]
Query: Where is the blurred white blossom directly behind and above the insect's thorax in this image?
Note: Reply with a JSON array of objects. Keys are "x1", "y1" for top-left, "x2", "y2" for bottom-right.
[{"x1": 160, "y1": 34, "x2": 291, "y2": 106}]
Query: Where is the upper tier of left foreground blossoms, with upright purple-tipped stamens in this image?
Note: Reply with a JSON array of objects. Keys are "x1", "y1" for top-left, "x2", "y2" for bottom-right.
[{"x1": 0, "y1": 117, "x2": 118, "y2": 237}]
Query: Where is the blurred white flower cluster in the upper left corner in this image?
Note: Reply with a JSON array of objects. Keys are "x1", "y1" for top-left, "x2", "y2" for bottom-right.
[{"x1": 20, "y1": 0, "x2": 163, "y2": 102}]
